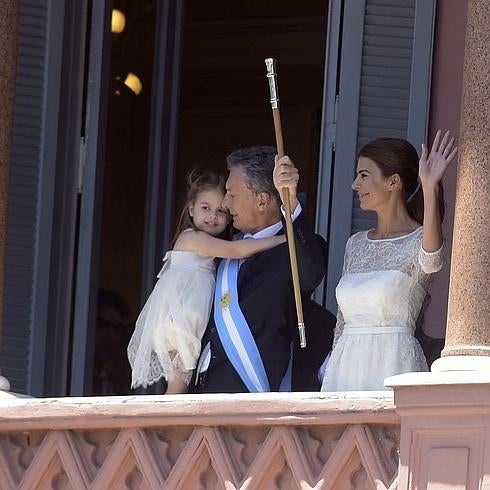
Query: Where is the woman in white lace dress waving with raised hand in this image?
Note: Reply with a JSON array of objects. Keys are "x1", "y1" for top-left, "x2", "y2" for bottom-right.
[{"x1": 322, "y1": 131, "x2": 457, "y2": 391}]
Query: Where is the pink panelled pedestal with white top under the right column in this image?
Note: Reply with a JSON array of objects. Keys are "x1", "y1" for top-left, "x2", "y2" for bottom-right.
[{"x1": 385, "y1": 370, "x2": 490, "y2": 490}]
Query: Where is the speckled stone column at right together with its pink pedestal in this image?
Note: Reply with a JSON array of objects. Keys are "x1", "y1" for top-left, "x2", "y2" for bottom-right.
[{"x1": 385, "y1": 0, "x2": 490, "y2": 490}]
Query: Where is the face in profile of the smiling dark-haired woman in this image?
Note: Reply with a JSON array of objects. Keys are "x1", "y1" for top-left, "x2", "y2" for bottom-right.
[{"x1": 352, "y1": 157, "x2": 394, "y2": 211}]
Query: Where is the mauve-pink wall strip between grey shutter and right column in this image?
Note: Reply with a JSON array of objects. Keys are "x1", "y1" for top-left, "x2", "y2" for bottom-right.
[{"x1": 424, "y1": 0, "x2": 468, "y2": 337}]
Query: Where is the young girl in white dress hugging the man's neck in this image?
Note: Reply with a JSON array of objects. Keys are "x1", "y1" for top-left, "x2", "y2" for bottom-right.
[{"x1": 128, "y1": 172, "x2": 286, "y2": 393}]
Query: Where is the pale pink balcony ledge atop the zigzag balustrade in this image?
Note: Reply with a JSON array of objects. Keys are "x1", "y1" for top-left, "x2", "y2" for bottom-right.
[{"x1": 0, "y1": 391, "x2": 399, "y2": 431}]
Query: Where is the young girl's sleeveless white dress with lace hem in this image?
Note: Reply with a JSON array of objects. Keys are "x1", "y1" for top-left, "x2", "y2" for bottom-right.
[{"x1": 128, "y1": 250, "x2": 216, "y2": 388}]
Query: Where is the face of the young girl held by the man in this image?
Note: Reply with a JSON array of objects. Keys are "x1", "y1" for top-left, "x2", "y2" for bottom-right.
[{"x1": 189, "y1": 189, "x2": 230, "y2": 236}]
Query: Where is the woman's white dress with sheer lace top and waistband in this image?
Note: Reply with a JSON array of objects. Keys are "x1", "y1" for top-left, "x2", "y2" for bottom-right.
[{"x1": 322, "y1": 227, "x2": 442, "y2": 391}]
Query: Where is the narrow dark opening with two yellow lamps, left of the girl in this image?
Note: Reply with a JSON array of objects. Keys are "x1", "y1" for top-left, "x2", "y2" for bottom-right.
[{"x1": 92, "y1": 0, "x2": 157, "y2": 395}]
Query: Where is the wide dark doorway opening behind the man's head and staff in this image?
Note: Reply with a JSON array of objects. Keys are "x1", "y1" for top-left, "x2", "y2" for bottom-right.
[{"x1": 176, "y1": 0, "x2": 327, "y2": 220}]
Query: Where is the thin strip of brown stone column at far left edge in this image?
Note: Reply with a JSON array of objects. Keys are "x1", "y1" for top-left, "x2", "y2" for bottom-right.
[{"x1": 0, "y1": 0, "x2": 20, "y2": 390}]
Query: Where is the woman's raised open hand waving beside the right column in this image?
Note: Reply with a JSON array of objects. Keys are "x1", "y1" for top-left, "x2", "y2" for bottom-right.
[{"x1": 419, "y1": 130, "x2": 458, "y2": 189}]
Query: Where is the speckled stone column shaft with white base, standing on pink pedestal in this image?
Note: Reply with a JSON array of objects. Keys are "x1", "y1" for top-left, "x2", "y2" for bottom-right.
[{"x1": 432, "y1": 0, "x2": 490, "y2": 371}]
